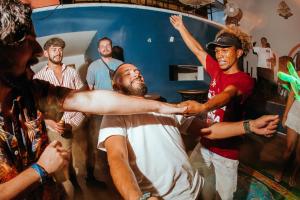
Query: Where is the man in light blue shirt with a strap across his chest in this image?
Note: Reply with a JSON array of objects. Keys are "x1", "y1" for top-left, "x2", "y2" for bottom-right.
[{"x1": 86, "y1": 37, "x2": 122, "y2": 186}]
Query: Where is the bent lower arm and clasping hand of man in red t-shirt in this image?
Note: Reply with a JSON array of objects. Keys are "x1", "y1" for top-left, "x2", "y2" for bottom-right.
[{"x1": 181, "y1": 85, "x2": 239, "y2": 114}]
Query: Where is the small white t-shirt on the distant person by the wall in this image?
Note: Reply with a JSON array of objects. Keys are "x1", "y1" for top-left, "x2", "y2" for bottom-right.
[{"x1": 253, "y1": 47, "x2": 273, "y2": 69}]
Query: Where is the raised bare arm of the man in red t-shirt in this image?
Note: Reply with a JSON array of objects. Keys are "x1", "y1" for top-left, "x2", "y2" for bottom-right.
[{"x1": 170, "y1": 15, "x2": 207, "y2": 68}]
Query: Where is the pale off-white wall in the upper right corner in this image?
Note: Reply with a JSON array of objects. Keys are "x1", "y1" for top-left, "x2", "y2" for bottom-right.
[{"x1": 233, "y1": 0, "x2": 300, "y2": 77}]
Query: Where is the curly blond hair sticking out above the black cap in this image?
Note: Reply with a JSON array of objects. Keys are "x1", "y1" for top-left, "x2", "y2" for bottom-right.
[{"x1": 216, "y1": 25, "x2": 252, "y2": 55}]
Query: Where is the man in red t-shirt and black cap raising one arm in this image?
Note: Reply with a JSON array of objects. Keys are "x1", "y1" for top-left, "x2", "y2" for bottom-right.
[{"x1": 170, "y1": 16, "x2": 254, "y2": 200}]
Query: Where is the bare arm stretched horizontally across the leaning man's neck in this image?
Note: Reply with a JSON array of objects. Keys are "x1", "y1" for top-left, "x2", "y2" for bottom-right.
[{"x1": 63, "y1": 90, "x2": 186, "y2": 115}]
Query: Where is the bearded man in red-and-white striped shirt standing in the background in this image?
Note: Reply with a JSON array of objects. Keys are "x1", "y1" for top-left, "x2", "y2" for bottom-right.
[{"x1": 33, "y1": 37, "x2": 85, "y2": 199}]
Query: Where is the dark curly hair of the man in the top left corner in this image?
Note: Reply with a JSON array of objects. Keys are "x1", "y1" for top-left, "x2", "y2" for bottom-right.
[{"x1": 0, "y1": 0, "x2": 32, "y2": 45}]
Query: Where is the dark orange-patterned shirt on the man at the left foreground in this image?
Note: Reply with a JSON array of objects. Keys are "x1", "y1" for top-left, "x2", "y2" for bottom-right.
[{"x1": 0, "y1": 80, "x2": 70, "y2": 200}]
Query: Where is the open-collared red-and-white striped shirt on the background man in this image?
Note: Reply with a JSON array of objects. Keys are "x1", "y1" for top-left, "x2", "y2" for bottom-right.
[{"x1": 33, "y1": 64, "x2": 85, "y2": 127}]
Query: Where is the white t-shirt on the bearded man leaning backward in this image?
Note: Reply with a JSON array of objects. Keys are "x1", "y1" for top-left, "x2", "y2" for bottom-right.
[{"x1": 98, "y1": 113, "x2": 203, "y2": 200}]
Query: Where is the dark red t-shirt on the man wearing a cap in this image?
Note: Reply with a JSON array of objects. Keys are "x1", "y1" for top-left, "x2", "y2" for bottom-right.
[{"x1": 201, "y1": 55, "x2": 254, "y2": 160}]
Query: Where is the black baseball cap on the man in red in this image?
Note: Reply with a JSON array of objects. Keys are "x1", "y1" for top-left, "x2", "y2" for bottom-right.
[{"x1": 206, "y1": 33, "x2": 243, "y2": 50}]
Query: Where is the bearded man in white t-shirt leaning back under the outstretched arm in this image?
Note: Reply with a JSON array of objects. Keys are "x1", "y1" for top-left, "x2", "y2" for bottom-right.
[{"x1": 98, "y1": 64, "x2": 278, "y2": 200}]
